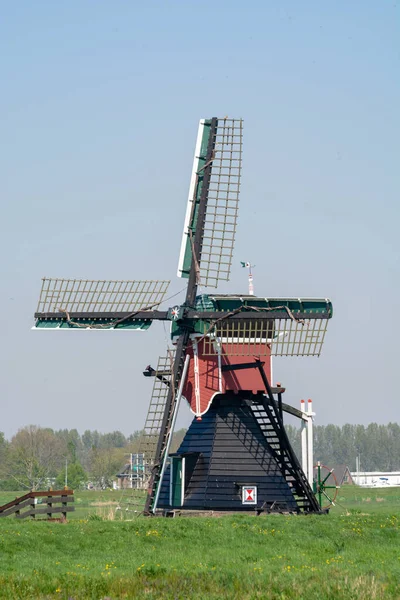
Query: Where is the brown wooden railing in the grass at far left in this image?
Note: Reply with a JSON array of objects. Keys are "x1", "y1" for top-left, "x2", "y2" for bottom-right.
[{"x1": 0, "y1": 489, "x2": 75, "y2": 520}]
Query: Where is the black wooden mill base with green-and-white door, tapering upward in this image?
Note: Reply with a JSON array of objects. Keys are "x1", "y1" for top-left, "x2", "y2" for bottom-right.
[{"x1": 157, "y1": 393, "x2": 321, "y2": 513}]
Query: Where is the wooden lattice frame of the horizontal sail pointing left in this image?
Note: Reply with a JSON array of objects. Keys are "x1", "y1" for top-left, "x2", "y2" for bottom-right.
[{"x1": 36, "y1": 277, "x2": 170, "y2": 313}]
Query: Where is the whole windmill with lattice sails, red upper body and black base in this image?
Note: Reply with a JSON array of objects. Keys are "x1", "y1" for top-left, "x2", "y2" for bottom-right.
[{"x1": 35, "y1": 117, "x2": 332, "y2": 514}]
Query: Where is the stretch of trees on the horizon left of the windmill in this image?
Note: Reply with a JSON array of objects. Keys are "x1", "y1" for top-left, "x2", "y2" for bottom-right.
[{"x1": 0, "y1": 425, "x2": 185, "y2": 490}]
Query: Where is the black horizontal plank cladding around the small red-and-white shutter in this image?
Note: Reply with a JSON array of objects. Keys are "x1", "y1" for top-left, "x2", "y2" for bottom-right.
[{"x1": 155, "y1": 397, "x2": 297, "y2": 511}]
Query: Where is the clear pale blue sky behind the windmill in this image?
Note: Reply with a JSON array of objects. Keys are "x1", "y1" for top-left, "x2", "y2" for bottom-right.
[{"x1": 0, "y1": 0, "x2": 400, "y2": 438}]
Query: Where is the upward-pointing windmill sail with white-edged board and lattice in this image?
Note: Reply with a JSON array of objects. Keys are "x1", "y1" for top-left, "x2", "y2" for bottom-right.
[{"x1": 178, "y1": 118, "x2": 243, "y2": 287}]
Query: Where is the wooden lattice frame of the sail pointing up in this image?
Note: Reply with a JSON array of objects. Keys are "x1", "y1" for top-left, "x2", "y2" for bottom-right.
[{"x1": 200, "y1": 119, "x2": 243, "y2": 287}]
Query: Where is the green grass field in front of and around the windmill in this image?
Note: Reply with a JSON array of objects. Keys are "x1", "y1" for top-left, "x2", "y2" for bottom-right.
[{"x1": 0, "y1": 486, "x2": 400, "y2": 600}]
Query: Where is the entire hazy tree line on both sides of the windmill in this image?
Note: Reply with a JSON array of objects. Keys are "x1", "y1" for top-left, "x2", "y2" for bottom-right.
[{"x1": 0, "y1": 423, "x2": 400, "y2": 490}]
